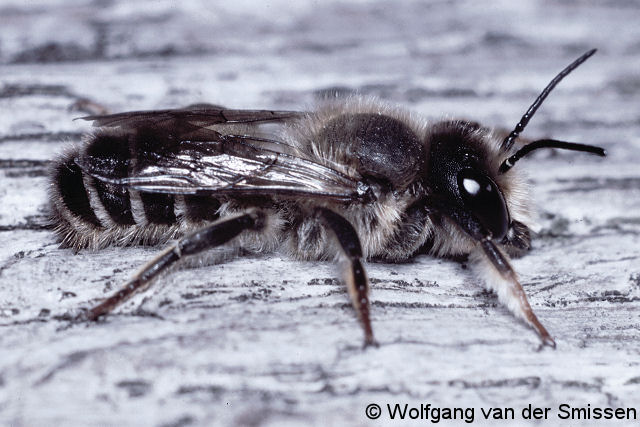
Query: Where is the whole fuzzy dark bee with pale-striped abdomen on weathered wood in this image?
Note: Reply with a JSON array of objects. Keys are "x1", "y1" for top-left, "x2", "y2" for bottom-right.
[{"x1": 51, "y1": 49, "x2": 605, "y2": 347}]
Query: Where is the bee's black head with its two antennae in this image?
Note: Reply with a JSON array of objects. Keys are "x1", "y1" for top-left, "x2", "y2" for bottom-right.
[{"x1": 425, "y1": 49, "x2": 605, "y2": 246}]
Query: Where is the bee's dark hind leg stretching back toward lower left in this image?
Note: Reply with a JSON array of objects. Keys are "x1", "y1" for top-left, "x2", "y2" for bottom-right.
[{"x1": 81, "y1": 211, "x2": 266, "y2": 320}]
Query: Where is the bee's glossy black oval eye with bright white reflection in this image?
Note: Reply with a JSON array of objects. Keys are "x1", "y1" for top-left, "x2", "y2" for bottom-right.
[{"x1": 458, "y1": 169, "x2": 509, "y2": 241}]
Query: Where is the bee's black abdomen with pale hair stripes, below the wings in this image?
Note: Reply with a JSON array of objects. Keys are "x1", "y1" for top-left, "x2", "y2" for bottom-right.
[{"x1": 50, "y1": 134, "x2": 220, "y2": 248}]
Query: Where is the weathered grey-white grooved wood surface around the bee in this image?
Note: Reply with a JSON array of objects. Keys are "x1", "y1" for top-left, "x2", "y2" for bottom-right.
[{"x1": 0, "y1": 0, "x2": 640, "y2": 426}]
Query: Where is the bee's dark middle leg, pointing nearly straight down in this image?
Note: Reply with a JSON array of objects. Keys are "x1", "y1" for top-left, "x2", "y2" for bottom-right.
[{"x1": 318, "y1": 208, "x2": 377, "y2": 347}]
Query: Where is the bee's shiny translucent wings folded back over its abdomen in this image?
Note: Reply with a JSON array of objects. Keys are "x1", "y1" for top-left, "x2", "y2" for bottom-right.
[{"x1": 76, "y1": 109, "x2": 365, "y2": 201}]
